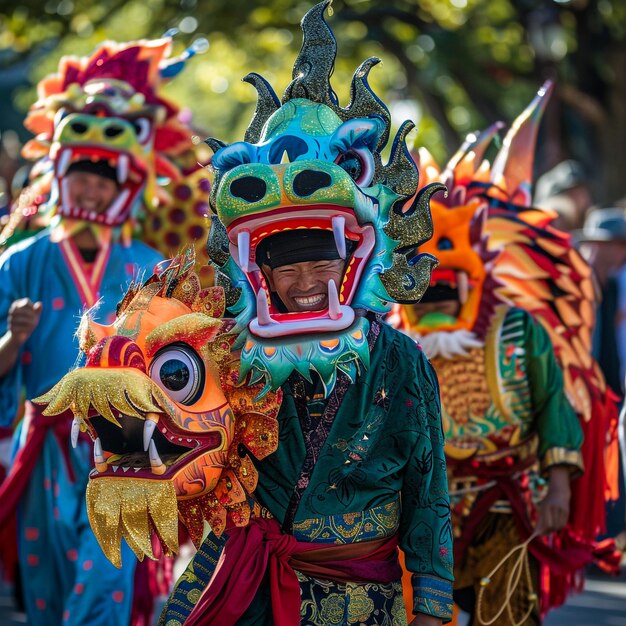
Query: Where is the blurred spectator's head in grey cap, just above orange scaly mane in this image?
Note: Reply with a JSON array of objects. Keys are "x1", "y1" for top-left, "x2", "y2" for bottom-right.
[{"x1": 534, "y1": 160, "x2": 592, "y2": 231}]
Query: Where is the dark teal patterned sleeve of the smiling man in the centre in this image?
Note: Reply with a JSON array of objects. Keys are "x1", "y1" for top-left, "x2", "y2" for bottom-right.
[{"x1": 397, "y1": 348, "x2": 453, "y2": 623}]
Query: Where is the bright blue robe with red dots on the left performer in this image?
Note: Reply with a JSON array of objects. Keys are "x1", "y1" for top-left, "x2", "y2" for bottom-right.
[{"x1": 0, "y1": 231, "x2": 162, "y2": 626}]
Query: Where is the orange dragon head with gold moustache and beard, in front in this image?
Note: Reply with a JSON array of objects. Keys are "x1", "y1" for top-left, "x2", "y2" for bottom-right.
[{"x1": 37, "y1": 251, "x2": 280, "y2": 565}]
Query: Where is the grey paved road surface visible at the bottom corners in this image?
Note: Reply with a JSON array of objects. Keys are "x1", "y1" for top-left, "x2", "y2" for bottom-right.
[{"x1": 0, "y1": 568, "x2": 626, "y2": 626}]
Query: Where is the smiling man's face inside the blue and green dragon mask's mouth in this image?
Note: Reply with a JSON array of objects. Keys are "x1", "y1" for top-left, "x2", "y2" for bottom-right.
[{"x1": 263, "y1": 259, "x2": 345, "y2": 313}]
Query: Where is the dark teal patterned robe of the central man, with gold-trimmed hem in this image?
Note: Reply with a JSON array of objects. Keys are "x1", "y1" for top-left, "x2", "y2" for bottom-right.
[{"x1": 162, "y1": 322, "x2": 452, "y2": 626}]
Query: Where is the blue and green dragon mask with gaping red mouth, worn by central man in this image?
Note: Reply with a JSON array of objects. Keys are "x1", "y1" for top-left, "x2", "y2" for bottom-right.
[{"x1": 207, "y1": 1, "x2": 438, "y2": 394}]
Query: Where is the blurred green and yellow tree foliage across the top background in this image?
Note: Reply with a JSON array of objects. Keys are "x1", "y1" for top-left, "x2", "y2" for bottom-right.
[{"x1": 0, "y1": 0, "x2": 626, "y2": 200}]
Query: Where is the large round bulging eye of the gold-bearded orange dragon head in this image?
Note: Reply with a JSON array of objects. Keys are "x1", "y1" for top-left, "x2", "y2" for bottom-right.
[{"x1": 150, "y1": 344, "x2": 205, "y2": 405}]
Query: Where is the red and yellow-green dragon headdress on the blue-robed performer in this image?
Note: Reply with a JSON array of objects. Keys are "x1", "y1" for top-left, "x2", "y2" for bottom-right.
[{"x1": 3, "y1": 37, "x2": 210, "y2": 276}]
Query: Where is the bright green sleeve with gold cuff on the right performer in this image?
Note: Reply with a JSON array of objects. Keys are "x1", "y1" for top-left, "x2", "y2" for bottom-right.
[{"x1": 525, "y1": 316, "x2": 583, "y2": 472}]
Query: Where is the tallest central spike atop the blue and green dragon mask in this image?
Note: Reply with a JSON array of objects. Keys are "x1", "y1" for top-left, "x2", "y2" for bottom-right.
[{"x1": 282, "y1": 0, "x2": 338, "y2": 110}]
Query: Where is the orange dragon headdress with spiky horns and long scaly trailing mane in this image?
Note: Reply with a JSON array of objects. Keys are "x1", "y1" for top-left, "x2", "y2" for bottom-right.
[{"x1": 394, "y1": 83, "x2": 616, "y2": 536}]
